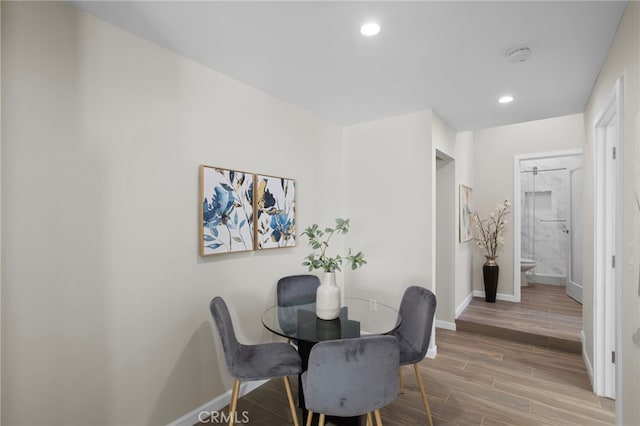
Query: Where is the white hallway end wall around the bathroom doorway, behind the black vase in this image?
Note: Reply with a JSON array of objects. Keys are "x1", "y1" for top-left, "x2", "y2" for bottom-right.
[{"x1": 473, "y1": 114, "x2": 584, "y2": 300}]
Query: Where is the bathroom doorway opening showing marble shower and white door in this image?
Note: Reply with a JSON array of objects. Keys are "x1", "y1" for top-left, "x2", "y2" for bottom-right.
[{"x1": 513, "y1": 150, "x2": 583, "y2": 304}]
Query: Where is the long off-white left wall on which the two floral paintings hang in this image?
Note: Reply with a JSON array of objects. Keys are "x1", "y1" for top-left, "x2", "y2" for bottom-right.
[{"x1": 1, "y1": 2, "x2": 342, "y2": 425}]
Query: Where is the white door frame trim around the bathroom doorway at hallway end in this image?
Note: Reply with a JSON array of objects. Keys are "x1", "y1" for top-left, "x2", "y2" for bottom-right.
[{"x1": 512, "y1": 149, "x2": 584, "y2": 303}]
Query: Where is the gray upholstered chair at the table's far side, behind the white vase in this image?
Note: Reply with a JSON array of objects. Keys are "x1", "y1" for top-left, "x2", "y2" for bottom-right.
[{"x1": 276, "y1": 275, "x2": 320, "y2": 340}]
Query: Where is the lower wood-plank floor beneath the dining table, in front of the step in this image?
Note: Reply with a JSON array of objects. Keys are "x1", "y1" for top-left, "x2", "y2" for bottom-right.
[{"x1": 201, "y1": 329, "x2": 615, "y2": 426}]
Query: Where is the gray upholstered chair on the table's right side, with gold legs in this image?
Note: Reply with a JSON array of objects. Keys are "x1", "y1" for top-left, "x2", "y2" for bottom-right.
[{"x1": 389, "y1": 286, "x2": 436, "y2": 426}]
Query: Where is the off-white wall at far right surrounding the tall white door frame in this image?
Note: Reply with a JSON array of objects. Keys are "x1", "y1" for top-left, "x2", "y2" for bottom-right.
[{"x1": 583, "y1": 2, "x2": 640, "y2": 425}]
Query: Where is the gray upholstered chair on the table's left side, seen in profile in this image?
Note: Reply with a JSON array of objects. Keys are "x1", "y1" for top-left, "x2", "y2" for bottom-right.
[{"x1": 209, "y1": 297, "x2": 302, "y2": 426}]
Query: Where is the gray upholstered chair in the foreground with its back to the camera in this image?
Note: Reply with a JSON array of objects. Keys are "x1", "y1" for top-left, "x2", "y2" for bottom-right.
[{"x1": 301, "y1": 336, "x2": 400, "y2": 426}]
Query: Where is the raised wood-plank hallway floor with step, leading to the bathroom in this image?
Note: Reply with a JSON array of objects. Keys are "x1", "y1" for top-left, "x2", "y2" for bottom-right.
[{"x1": 456, "y1": 284, "x2": 582, "y2": 353}]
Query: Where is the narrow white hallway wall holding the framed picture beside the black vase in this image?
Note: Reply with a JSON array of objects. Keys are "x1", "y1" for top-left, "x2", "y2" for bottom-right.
[{"x1": 454, "y1": 132, "x2": 475, "y2": 316}]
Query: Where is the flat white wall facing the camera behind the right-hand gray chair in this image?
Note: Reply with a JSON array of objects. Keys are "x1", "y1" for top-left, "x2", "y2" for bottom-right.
[{"x1": 344, "y1": 111, "x2": 435, "y2": 306}]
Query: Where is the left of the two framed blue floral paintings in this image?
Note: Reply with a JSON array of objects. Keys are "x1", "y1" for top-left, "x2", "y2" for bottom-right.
[{"x1": 200, "y1": 166, "x2": 253, "y2": 256}]
